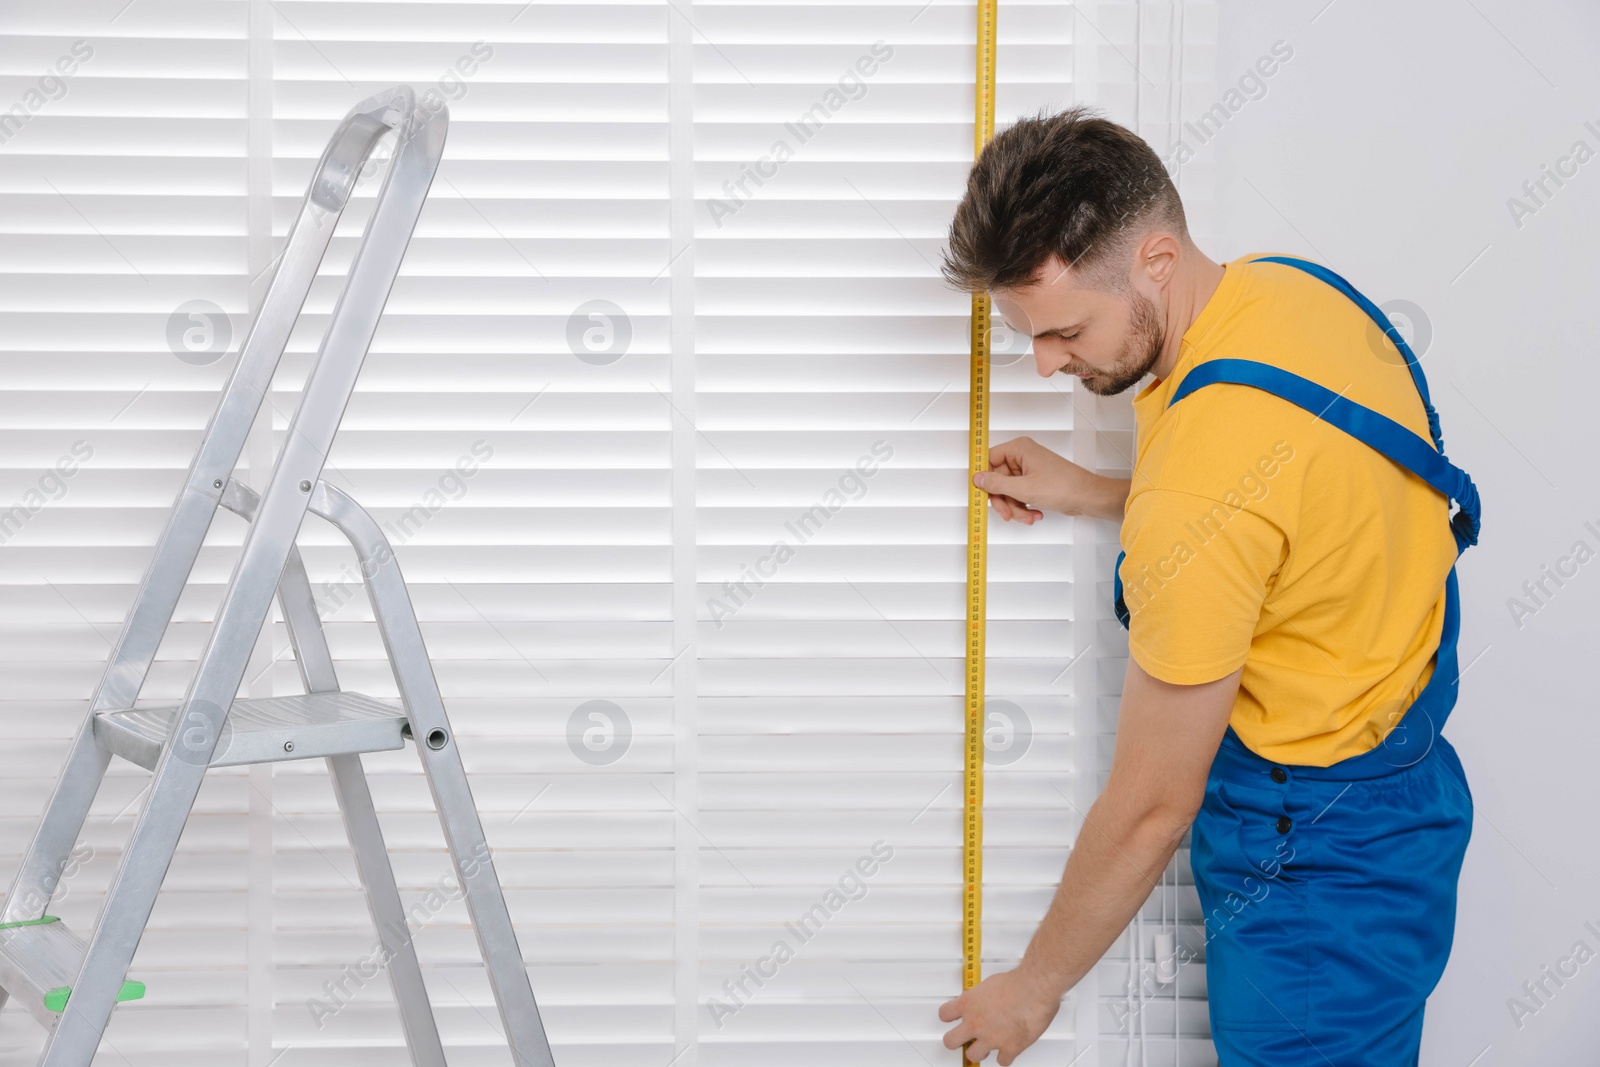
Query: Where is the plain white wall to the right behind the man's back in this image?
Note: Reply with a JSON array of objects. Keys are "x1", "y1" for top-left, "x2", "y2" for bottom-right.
[{"x1": 1209, "y1": 0, "x2": 1600, "y2": 1067}]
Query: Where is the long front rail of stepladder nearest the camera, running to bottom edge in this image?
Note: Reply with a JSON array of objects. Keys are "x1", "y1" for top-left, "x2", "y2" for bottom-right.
[{"x1": 38, "y1": 86, "x2": 450, "y2": 1067}]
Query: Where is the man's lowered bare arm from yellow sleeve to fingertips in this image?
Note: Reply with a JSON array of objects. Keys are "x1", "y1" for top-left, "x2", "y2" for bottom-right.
[{"x1": 939, "y1": 657, "x2": 1240, "y2": 1067}]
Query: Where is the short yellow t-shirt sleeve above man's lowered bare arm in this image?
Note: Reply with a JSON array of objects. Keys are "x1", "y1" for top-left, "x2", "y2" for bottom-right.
[{"x1": 1122, "y1": 490, "x2": 1288, "y2": 685}]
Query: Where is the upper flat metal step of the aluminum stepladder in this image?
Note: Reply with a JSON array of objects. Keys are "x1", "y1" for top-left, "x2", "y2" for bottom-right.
[{"x1": 94, "y1": 689, "x2": 406, "y2": 771}]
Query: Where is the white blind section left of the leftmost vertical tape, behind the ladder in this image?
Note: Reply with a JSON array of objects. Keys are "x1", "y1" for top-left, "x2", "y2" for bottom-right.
[{"x1": 0, "y1": 2, "x2": 259, "y2": 1065}]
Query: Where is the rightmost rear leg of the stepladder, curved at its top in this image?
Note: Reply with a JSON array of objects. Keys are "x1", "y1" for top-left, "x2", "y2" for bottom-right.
[{"x1": 310, "y1": 482, "x2": 555, "y2": 1067}]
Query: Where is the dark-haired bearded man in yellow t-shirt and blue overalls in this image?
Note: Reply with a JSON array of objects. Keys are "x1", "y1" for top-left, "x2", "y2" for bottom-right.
[{"x1": 939, "y1": 109, "x2": 1478, "y2": 1067}]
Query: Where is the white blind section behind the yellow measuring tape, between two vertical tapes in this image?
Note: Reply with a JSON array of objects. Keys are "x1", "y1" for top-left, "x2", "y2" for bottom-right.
[{"x1": 694, "y1": 3, "x2": 1077, "y2": 1067}]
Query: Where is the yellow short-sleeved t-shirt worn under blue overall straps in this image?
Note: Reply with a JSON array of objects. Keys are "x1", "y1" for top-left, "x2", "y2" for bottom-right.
[{"x1": 1122, "y1": 258, "x2": 1456, "y2": 766}]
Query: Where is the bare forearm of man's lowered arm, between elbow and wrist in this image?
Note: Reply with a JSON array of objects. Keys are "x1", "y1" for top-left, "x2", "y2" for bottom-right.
[{"x1": 1019, "y1": 793, "x2": 1187, "y2": 1000}]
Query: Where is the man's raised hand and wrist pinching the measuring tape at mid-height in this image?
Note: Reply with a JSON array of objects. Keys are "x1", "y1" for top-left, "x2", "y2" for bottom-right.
[{"x1": 973, "y1": 437, "x2": 1130, "y2": 526}]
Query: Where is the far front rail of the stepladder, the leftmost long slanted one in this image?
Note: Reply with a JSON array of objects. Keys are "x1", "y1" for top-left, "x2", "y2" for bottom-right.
[{"x1": 0, "y1": 93, "x2": 419, "y2": 927}]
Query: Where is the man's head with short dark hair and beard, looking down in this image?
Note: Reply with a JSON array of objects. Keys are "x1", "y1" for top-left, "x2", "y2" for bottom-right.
[{"x1": 944, "y1": 107, "x2": 1192, "y2": 395}]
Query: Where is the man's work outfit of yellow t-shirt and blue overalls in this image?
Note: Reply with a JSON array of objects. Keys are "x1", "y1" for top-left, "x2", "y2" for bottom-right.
[{"x1": 1114, "y1": 256, "x2": 1478, "y2": 1067}]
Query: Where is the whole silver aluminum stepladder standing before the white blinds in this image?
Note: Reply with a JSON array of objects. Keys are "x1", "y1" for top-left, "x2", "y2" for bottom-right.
[{"x1": 0, "y1": 86, "x2": 554, "y2": 1067}]
